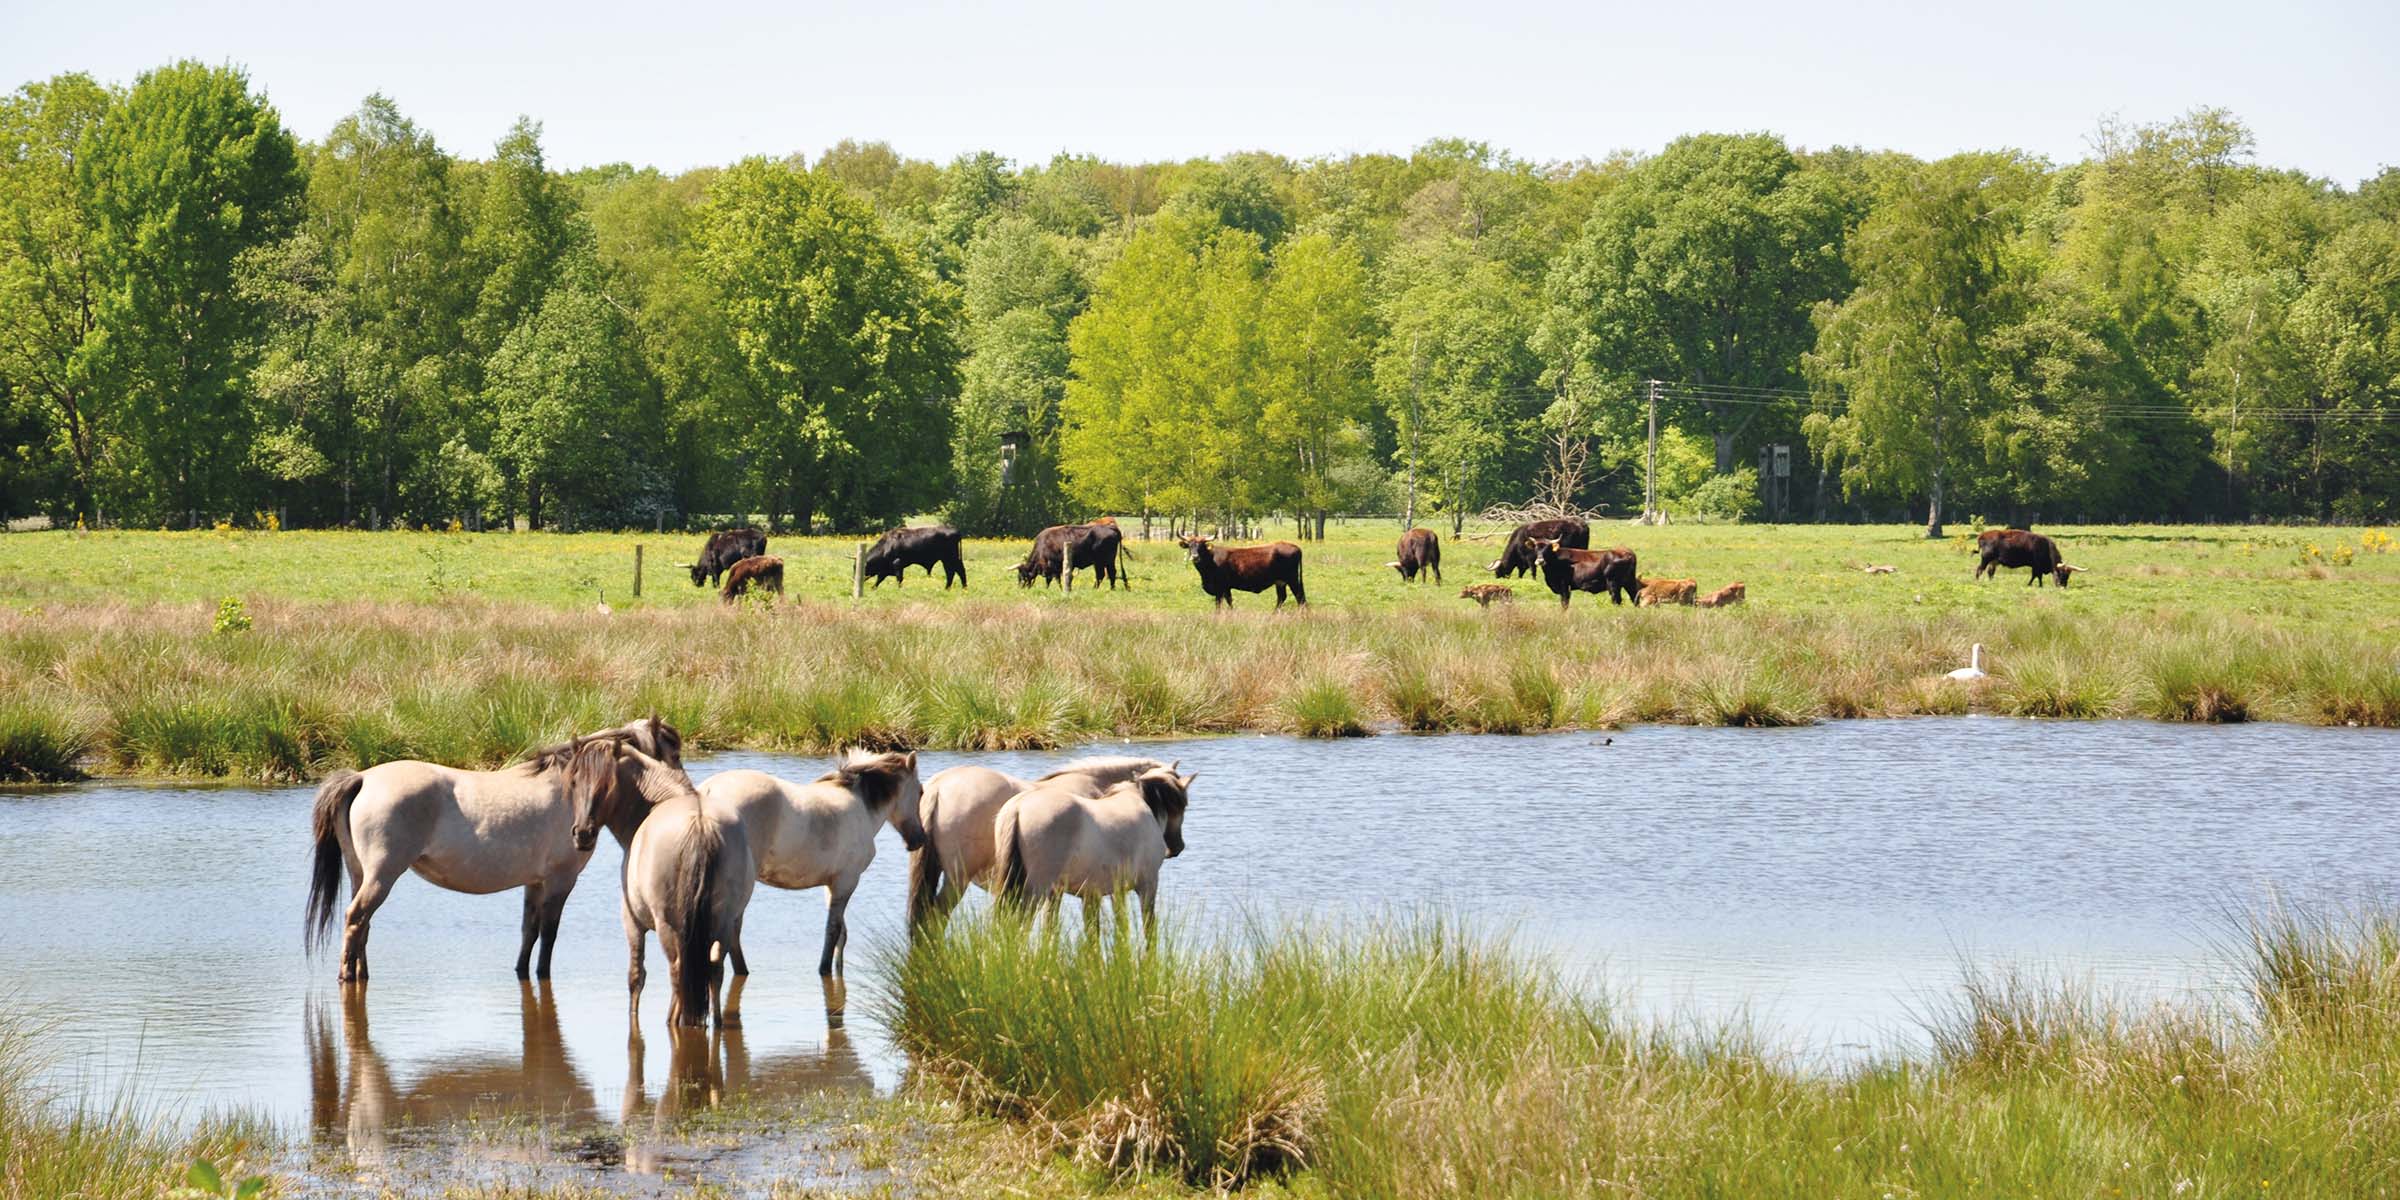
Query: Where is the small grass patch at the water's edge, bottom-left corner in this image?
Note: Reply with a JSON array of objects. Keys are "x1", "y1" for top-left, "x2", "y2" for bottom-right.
[{"x1": 0, "y1": 1018, "x2": 274, "y2": 1200}]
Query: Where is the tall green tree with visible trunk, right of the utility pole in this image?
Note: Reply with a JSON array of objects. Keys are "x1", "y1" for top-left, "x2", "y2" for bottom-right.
[{"x1": 1805, "y1": 154, "x2": 2040, "y2": 538}]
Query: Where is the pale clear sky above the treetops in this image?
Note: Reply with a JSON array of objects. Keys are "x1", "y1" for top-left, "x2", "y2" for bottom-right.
[{"x1": 0, "y1": 0, "x2": 2400, "y2": 185}]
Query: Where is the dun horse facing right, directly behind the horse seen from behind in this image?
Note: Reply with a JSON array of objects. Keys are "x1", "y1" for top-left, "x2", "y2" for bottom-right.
[{"x1": 701, "y1": 751, "x2": 924, "y2": 984}]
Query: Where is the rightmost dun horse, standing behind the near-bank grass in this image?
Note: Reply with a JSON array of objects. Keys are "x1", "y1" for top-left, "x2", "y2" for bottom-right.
[{"x1": 991, "y1": 768, "x2": 1200, "y2": 936}]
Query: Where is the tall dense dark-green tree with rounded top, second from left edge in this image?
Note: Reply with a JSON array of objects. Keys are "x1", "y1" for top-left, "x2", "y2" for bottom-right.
[{"x1": 77, "y1": 62, "x2": 302, "y2": 518}]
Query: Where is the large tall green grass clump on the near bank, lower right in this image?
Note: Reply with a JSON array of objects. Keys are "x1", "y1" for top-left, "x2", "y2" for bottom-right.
[{"x1": 883, "y1": 914, "x2": 2400, "y2": 1200}]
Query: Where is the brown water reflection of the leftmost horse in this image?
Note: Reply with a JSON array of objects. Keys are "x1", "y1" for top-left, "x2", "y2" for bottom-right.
[{"x1": 305, "y1": 982, "x2": 598, "y2": 1162}]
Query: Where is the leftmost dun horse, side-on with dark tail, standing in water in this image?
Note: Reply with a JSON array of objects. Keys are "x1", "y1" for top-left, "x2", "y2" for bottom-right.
[{"x1": 305, "y1": 718, "x2": 684, "y2": 982}]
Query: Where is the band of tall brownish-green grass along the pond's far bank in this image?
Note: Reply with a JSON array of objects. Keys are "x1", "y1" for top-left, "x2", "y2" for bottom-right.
[{"x1": 0, "y1": 598, "x2": 2400, "y2": 782}]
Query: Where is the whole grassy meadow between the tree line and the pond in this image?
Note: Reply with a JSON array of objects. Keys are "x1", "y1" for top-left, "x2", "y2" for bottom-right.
[{"x1": 0, "y1": 523, "x2": 2400, "y2": 780}]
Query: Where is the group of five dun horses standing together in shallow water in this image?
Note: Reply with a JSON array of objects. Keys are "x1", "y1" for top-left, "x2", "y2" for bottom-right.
[{"x1": 305, "y1": 718, "x2": 1195, "y2": 1027}]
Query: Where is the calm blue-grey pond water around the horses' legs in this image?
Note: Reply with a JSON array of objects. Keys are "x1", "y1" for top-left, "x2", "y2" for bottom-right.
[{"x1": 0, "y1": 718, "x2": 2400, "y2": 1145}]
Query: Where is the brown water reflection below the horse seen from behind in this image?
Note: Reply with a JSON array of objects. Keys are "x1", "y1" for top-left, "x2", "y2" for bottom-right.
[{"x1": 622, "y1": 977, "x2": 876, "y2": 1174}]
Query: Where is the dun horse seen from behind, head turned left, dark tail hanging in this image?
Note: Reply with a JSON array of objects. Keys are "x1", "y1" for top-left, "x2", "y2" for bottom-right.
[{"x1": 566, "y1": 742, "x2": 758, "y2": 1030}]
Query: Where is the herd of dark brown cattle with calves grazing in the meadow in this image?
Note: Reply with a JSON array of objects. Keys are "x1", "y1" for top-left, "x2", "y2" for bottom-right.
[{"x1": 684, "y1": 516, "x2": 2081, "y2": 610}]
